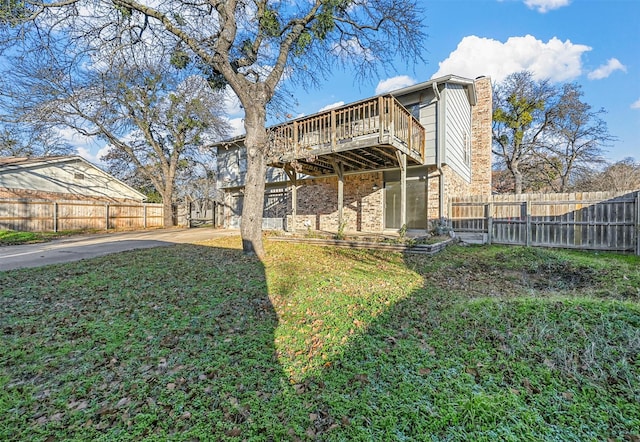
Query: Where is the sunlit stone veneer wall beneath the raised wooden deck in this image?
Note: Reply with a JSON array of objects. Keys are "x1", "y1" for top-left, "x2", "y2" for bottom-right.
[{"x1": 287, "y1": 172, "x2": 384, "y2": 232}]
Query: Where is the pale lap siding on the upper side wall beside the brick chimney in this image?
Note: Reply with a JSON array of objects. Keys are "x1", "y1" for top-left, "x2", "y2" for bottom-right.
[{"x1": 442, "y1": 83, "x2": 471, "y2": 182}]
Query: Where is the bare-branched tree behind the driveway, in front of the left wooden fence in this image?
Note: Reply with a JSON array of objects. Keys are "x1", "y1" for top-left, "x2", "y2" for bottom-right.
[{"x1": 2, "y1": 41, "x2": 226, "y2": 226}]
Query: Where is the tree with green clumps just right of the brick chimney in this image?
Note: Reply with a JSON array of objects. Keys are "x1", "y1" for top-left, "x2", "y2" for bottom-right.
[{"x1": 493, "y1": 71, "x2": 556, "y2": 193}]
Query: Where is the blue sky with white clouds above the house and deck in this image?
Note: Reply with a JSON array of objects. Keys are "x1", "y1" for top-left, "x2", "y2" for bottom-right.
[{"x1": 74, "y1": 0, "x2": 640, "y2": 161}]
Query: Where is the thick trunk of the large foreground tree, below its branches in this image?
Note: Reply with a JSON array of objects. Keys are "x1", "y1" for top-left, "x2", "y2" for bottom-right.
[{"x1": 240, "y1": 108, "x2": 267, "y2": 258}]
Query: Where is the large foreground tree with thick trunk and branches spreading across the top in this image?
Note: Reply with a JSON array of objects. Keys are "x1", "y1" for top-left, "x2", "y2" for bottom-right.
[{"x1": 5, "y1": 0, "x2": 424, "y2": 255}]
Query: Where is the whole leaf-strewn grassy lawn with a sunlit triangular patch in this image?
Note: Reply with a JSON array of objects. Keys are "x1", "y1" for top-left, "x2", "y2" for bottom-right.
[{"x1": 0, "y1": 238, "x2": 640, "y2": 441}]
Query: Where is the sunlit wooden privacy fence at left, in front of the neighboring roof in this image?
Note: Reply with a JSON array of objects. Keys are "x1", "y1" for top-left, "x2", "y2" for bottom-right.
[{"x1": 0, "y1": 200, "x2": 164, "y2": 232}]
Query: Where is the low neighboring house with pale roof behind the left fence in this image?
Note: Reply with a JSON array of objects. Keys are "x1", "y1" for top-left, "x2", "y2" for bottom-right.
[{"x1": 0, "y1": 156, "x2": 146, "y2": 202}]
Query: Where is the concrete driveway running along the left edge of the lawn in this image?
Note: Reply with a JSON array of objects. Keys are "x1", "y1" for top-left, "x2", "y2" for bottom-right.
[{"x1": 0, "y1": 228, "x2": 239, "y2": 271}]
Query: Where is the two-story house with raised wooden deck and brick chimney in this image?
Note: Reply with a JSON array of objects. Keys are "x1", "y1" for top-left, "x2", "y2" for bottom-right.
[{"x1": 218, "y1": 75, "x2": 492, "y2": 232}]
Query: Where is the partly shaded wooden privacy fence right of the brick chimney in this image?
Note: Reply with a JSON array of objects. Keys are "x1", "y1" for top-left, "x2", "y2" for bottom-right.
[{"x1": 449, "y1": 191, "x2": 640, "y2": 255}]
